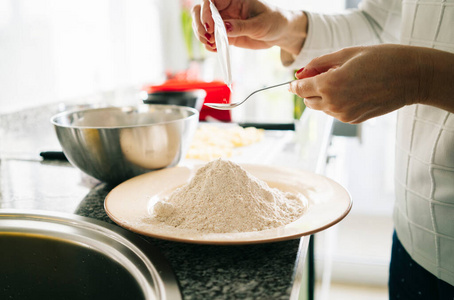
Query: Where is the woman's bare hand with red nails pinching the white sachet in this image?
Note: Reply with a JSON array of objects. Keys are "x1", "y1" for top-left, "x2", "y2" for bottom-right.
[{"x1": 192, "y1": 0, "x2": 307, "y2": 55}]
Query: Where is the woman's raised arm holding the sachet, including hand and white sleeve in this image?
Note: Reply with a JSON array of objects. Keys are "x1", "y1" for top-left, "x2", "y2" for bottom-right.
[{"x1": 193, "y1": 0, "x2": 401, "y2": 69}]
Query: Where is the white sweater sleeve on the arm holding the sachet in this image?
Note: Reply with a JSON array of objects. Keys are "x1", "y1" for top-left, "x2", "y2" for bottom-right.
[{"x1": 281, "y1": 0, "x2": 401, "y2": 69}]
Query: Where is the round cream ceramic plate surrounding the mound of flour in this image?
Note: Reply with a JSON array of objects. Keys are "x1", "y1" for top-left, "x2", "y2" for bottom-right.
[{"x1": 104, "y1": 164, "x2": 352, "y2": 245}]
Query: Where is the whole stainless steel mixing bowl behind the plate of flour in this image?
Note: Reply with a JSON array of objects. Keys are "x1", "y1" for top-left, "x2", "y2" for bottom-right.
[{"x1": 51, "y1": 104, "x2": 199, "y2": 184}]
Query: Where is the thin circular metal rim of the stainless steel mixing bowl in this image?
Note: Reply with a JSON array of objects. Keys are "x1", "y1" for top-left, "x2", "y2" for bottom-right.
[{"x1": 50, "y1": 103, "x2": 199, "y2": 129}]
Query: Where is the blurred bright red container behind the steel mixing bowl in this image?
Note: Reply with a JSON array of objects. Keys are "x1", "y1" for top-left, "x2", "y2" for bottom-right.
[{"x1": 144, "y1": 79, "x2": 232, "y2": 122}]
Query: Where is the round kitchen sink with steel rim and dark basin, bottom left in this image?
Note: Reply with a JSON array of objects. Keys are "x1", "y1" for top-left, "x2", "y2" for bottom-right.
[{"x1": 0, "y1": 210, "x2": 181, "y2": 300}]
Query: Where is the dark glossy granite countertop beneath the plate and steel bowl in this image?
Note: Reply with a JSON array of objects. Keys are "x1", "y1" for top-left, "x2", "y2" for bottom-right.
[{"x1": 0, "y1": 102, "x2": 330, "y2": 299}]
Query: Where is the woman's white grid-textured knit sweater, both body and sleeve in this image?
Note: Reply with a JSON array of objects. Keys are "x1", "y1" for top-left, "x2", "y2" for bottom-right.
[{"x1": 291, "y1": 0, "x2": 454, "y2": 285}]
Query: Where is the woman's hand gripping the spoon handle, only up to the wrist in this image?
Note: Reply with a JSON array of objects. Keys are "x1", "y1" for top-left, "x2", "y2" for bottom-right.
[{"x1": 290, "y1": 45, "x2": 424, "y2": 124}]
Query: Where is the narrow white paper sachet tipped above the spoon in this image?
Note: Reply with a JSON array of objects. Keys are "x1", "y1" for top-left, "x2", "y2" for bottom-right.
[{"x1": 210, "y1": 1, "x2": 232, "y2": 89}]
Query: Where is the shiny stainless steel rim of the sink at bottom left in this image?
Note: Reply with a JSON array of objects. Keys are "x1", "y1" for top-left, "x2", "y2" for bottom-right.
[{"x1": 0, "y1": 209, "x2": 181, "y2": 300}]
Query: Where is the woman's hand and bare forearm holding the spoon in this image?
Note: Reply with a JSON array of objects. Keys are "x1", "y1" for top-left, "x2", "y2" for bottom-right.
[{"x1": 290, "y1": 45, "x2": 454, "y2": 124}]
